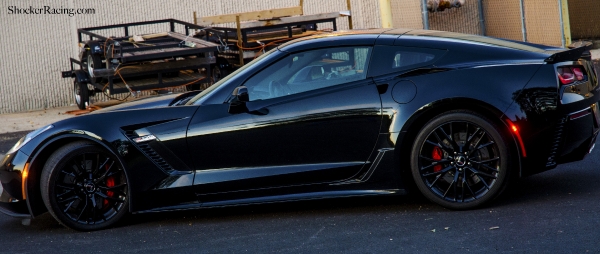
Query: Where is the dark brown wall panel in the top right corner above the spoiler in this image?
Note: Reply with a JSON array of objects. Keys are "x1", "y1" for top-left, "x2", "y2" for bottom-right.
[{"x1": 569, "y1": 0, "x2": 600, "y2": 40}]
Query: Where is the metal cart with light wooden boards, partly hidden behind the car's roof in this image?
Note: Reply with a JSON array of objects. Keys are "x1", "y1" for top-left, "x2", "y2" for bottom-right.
[{"x1": 194, "y1": 6, "x2": 351, "y2": 78}]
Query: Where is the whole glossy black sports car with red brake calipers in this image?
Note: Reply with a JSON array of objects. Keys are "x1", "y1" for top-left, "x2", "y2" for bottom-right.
[{"x1": 0, "y1": 29, "x2": 600, "y2": 230}]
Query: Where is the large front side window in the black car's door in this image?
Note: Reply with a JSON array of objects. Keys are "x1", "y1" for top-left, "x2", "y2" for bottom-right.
[{"x1": 244, "y1": 46, "x2": 372, "y2": 101}]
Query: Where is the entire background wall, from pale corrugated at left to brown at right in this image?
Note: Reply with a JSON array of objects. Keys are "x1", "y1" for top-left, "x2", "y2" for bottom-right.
[{"x1": 0, "y1": 0, "x2": 580, "y2": 114}]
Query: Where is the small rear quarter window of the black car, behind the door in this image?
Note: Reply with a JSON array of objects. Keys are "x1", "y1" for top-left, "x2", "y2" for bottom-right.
[{"x1": 369, "y1": 45, "x2": 446, "y2": 77}]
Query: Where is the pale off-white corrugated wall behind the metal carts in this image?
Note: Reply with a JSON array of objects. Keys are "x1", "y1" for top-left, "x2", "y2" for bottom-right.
[{"x1": 0, "y1": 0, "x2": 372, "y2": 114}]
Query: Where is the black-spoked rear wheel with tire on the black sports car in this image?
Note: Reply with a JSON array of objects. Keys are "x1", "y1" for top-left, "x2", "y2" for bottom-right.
[{"x1": 410, "y1": 111, "x2": 511, "y2": 210}]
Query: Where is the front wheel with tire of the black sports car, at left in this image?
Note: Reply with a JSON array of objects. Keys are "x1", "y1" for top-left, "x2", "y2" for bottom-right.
[{"x1": 40, "y1": 141, "x2": 129, "y2": 231}]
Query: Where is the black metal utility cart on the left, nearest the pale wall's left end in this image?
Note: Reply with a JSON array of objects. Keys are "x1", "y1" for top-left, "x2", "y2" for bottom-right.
[{"x1": 62, "y1": 19, "x2": 219, "y2": 109}]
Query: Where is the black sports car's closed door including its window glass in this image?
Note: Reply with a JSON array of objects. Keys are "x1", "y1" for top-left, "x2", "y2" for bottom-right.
[{"x1": 188, "y1": 46, "x2": 381, "y2": 193}]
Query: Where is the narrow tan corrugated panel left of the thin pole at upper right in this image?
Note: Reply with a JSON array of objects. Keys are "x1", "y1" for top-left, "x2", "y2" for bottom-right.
[{"x1": 483, "y1": 0, "x2": 523, "y2": 41}]
